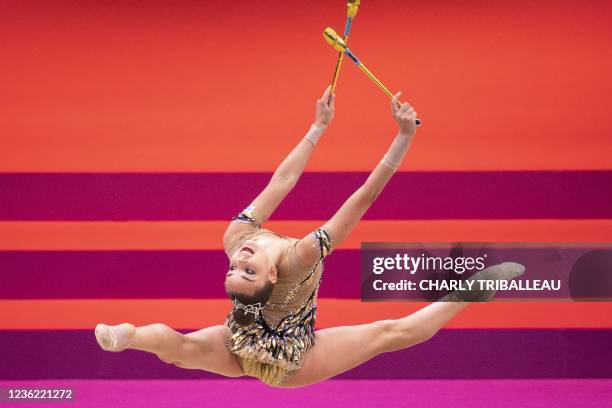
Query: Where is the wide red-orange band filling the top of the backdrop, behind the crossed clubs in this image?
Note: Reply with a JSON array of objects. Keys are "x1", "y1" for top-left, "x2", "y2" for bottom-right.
[{"x1": 0, "y1": 0, "x2": 612, "y2": 172}]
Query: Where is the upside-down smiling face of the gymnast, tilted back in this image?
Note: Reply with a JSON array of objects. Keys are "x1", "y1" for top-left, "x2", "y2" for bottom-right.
[{"x1": 225, "y1": 240, "x2": 277, "y2": 296}]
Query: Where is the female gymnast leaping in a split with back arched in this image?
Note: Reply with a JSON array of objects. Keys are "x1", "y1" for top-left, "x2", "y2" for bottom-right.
[{"x1": 95, "y1": 87, "x2": 524, "y2": 387}]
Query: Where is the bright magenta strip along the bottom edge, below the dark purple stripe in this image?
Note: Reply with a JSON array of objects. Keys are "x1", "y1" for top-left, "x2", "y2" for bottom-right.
[{"x1": 0, "y1": 379, "x2": 612, "y2": 408}]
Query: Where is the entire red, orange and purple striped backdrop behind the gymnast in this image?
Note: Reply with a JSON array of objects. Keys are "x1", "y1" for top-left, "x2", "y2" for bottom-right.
[{"x1": 0, "y1": 0, "x2": 612, "y2": 379}]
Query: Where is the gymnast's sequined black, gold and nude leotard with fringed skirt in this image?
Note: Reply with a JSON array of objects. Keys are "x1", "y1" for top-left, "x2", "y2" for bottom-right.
[{"x1": 225, "y1": 207, "x2": 332, "y2": 385}]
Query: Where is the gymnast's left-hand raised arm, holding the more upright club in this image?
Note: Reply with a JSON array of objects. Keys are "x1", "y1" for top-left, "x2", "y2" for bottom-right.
[{"x1": 223, "y1": 86, "x2": 335, "y2": 248}]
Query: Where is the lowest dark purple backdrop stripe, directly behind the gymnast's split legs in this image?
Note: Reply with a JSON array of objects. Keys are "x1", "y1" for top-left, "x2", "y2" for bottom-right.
[{"x1": 0, "y1": 328, "x2": 612, "y2": 379}]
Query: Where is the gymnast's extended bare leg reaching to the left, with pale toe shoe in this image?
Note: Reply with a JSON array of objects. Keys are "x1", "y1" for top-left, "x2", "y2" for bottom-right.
[{"x1": 95, "y1": 323, "x2": 244, "y2": 377}]
